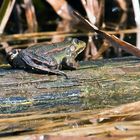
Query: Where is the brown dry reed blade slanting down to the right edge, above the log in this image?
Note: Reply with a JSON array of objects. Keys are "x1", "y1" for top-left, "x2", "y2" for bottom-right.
[{"x1": 73, "y1": 11, "x2": 140, "y2": 57}]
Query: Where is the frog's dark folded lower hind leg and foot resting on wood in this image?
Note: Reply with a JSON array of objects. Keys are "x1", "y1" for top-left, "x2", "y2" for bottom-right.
[{"x1": 22, "y1": 55, "x2": 68, "y2": 79}]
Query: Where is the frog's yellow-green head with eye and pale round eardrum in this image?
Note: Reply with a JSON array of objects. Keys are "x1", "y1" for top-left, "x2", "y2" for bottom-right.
[{"x1": 66, "y1": 38, "x2": 86, "y2": 58}]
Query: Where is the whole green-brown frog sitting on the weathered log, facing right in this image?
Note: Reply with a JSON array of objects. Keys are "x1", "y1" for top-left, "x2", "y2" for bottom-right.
[{"x1": 7, "y1": 38, "x2": 86, "y2": 78}]
